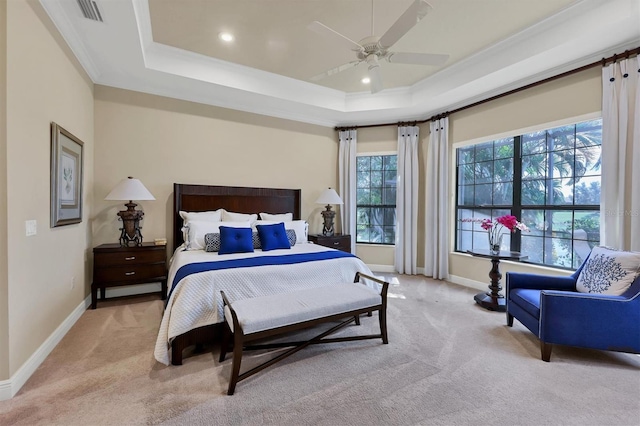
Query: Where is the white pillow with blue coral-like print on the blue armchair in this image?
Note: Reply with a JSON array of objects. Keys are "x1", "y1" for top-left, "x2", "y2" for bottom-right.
[{"x1": 576, "y1": 247, "x2": 640, "y2": 296}]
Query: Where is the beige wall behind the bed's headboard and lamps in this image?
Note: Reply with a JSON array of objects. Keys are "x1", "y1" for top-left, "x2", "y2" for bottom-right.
[{"x1": 92, "y1": 86, "x2": 338, "y2": 253}]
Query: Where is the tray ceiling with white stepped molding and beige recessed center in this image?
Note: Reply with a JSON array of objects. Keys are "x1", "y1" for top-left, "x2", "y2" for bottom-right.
[{"x1": 40, "y1": 0, "x2": 640, "y2": 126}]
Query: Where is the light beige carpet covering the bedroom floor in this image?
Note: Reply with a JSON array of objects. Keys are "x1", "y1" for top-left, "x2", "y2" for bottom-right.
[{"x1": 0, "y1": 275, "x2": 640, "y2": 425}]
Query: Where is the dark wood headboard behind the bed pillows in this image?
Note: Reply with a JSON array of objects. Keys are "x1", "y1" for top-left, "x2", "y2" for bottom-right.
[{"x1": 173, "y1": 183, "x2": 302, "y2": 250}]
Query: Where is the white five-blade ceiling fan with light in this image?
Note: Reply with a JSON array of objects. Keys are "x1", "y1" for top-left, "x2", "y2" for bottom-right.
[{"x1": 308, "y1": 0, "x2": 449, "y2": 93}]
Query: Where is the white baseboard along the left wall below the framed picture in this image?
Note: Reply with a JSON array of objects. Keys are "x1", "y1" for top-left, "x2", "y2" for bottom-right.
[{"x1": 0, "y1": 296, "x2": 91, "y2": 401}]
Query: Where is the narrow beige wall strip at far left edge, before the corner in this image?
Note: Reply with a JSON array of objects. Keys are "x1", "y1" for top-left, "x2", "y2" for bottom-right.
[{"x1": 0, "y1": 1, "x2": 9, "y2": 381}]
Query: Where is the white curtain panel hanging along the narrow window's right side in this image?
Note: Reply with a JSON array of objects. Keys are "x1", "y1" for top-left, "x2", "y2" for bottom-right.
[{"x1": 395, "y1": 126, "x2": 420, "y2": 275}]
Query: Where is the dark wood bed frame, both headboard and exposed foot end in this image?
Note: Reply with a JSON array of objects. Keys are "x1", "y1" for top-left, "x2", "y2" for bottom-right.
[{"x1": 169, "y1": 183, "x2": 302, "y2": 365}]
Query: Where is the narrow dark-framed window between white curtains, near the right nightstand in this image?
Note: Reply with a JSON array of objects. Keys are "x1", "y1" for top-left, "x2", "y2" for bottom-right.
[{"x1": 356, "y1": 155, "x2": 398, "y2": 245}]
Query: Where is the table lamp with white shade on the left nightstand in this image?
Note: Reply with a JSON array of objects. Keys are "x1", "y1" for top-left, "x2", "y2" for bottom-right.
[{"x1": 105, "y1": 176, "x2": 155, "y2": 247}]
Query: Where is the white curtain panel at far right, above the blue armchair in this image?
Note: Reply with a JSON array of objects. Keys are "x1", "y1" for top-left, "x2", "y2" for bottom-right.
[{"x1": 600, "y1": 57, "x2": 640, "y2": 251}]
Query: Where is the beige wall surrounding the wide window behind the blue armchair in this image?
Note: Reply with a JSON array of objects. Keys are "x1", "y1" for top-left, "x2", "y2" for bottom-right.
[{"x1": 449, "y1": 67, "x2": 602, "y2": 284}]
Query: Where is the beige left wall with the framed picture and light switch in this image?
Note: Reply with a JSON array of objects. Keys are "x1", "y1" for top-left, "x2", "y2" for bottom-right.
[{"x1": 5, "y1": 0, "x2": 94, "y2": 375}]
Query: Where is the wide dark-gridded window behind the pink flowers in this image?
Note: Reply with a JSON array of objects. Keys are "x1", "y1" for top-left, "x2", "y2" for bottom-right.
[{"x1": 456, "y1": 119, "x2": 602, "y2": 268}]
